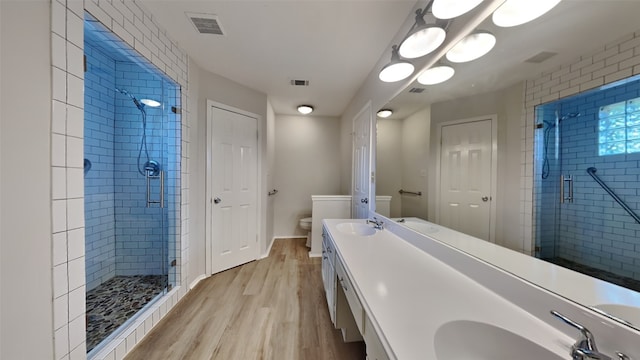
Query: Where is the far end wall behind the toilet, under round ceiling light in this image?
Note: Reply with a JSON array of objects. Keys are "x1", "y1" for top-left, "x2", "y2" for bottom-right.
[{"x1": 274, "y1": 115, "x2": 344, "y2": 237}]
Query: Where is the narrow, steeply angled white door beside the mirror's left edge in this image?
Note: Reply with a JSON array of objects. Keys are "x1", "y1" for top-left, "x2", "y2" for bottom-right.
[{"x1": 351, "y1": 105, "x2": 371, "y2": 219}]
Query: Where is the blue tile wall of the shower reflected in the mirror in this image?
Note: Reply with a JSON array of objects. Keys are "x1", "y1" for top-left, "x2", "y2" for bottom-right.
[{"x1": 536, "y1": 81, "x2": 640, "y2": 279}]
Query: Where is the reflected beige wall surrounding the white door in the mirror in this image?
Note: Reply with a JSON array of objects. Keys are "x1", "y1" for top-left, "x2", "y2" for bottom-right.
[{"x1": 429, "y1": 83, "x2": 524, "y2": 250}]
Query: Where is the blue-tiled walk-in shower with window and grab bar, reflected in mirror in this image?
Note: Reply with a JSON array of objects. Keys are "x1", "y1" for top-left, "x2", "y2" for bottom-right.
[{"x1": 534, "y1": 74, "x2": 640, "y2": 291}]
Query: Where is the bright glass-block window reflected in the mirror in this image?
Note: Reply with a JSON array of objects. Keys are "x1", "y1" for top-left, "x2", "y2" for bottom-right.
[{"x1": 598, "y1": 98, "x2": 640, "y2": 156}]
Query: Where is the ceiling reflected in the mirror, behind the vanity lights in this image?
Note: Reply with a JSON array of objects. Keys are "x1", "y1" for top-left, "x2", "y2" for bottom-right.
[{"x1": 386, "y1": 0, "x2": 640, "y2": 118}]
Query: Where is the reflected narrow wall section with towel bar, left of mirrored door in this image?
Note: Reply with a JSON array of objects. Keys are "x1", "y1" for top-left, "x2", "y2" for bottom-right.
[{"x1": 397, "y1": 107, "x2": 431, "y2": 219}]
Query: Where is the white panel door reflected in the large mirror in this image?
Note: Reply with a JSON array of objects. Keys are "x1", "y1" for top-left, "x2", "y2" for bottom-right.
[{"x1": 439, "y1": 119, "x2": 492, "y2": 240}]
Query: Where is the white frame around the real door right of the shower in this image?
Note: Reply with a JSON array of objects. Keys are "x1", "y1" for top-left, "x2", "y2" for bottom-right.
[{"x1": 204, "y1": 99, "x2": 264, "y2": 276}]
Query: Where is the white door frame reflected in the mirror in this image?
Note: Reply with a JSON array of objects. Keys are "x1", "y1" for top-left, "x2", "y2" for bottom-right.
[{"x1": 434, "y1": 114, "x2": 498, "y2": 243}]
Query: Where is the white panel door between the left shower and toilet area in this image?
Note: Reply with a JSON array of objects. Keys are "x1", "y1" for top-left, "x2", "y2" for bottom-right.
[{"x1": 208, "y1": 106, "x2": 258, "y2": 273}]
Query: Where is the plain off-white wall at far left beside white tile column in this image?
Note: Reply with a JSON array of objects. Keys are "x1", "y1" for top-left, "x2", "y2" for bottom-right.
[{"x1": 0, "y1": 0, "x2": 54, "y2": 359}]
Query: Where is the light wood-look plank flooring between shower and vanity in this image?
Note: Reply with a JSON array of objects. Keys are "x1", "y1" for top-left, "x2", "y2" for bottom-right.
[{"x1": 125, "y1": 239, "x2": 366, "y2": 360}]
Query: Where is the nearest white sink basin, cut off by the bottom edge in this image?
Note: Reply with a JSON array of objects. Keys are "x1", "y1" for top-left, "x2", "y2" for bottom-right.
[{"x1": 434, "y1": 320, "x2": 567, "y2": 360}]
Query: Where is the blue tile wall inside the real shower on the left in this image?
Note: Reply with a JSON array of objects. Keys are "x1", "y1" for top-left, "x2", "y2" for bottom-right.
[{"x1": 85, "y1": 40, "x2": 181, "y2": 290}]
